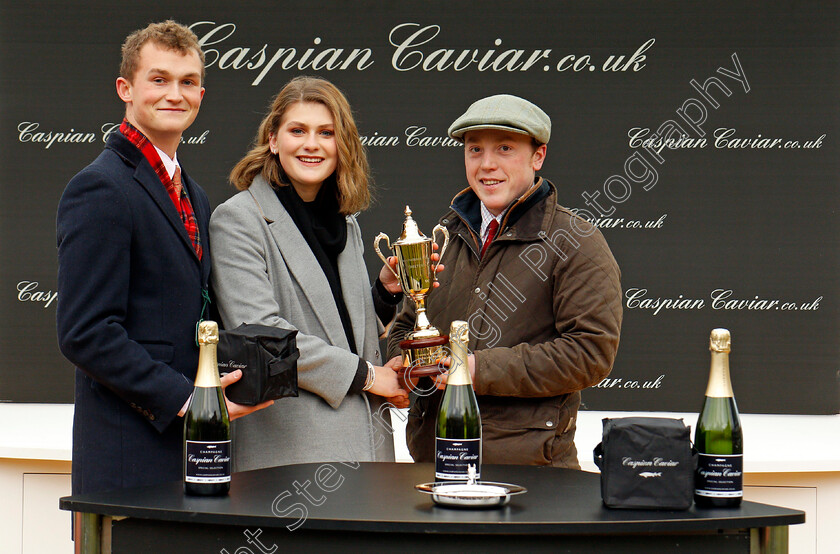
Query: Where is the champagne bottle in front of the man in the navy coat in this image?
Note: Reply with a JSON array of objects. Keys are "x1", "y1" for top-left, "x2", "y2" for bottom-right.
[{"x1": 184, "y1": 321, "x2": 230, "y2": 495}]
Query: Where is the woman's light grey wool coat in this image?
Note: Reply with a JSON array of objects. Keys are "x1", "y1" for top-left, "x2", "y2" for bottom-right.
[{"x1": 210, "y1": 176, "x2": 394, "y2": 471}]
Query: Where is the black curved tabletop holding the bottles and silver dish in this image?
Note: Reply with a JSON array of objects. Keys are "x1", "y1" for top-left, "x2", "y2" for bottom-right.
[{"x1": 55, "y1": 462, "x2": 805, "y2": 534}]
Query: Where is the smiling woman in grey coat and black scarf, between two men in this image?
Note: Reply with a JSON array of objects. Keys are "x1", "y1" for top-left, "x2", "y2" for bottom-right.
[{"x1": 210, "y1": 77, "x2": 408, "y2": 471}]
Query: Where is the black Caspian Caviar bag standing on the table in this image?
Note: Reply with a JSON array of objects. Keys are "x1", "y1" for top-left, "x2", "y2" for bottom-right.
[{"x1": 594, "y1": 417, "x2": 697, "y2": 510}]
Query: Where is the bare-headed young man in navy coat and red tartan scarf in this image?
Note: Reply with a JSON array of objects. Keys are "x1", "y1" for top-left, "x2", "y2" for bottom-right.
[{"x1": 57, "y1": 21, "x2": 263, "y2": 494}]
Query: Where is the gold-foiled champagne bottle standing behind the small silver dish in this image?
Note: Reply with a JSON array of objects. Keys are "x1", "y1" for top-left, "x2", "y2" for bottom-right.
[{"x1": 435, "y1": 321, "x2": 481, "y2": 481}]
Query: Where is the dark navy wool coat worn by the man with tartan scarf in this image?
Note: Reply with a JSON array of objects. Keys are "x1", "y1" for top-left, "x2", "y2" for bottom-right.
[{"x1": 57, "y1": 132, "x2": 210, "y2": 494}]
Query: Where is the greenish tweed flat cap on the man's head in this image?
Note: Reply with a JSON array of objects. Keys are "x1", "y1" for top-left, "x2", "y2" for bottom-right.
[{"x1": 449, "y1": 94, "x2": 551, "y2": 144}]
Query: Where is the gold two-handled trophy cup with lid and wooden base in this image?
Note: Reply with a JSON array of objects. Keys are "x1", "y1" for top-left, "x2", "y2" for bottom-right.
[{"x1": 373, "y1": 206, "x2": 449, "y2": 377}]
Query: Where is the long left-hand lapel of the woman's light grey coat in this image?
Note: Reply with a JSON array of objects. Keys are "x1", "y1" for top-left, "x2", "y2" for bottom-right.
[{"x1": 248, "y1": 176, "x2": 355, "y2": 349}]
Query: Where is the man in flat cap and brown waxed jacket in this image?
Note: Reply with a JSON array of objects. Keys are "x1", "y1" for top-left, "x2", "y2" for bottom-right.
[{"x1": 388, "y1": 94, "x2": 622, "y2": 468}]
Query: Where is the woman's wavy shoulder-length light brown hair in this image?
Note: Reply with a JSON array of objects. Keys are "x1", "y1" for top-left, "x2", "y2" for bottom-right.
[{"x1": 229, "y1": 77, "x2": 370, "y2": 215}]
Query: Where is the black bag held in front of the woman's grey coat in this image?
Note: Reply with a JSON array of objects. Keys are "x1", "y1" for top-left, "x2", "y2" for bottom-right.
[{"x1": 217, "y1": 323, "x2": 300, "y2": 406}]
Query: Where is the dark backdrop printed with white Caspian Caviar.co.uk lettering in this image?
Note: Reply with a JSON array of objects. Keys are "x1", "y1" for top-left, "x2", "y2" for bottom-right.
[{"x1": 0, "y1": 0, "x2": 840, "y2": 414}]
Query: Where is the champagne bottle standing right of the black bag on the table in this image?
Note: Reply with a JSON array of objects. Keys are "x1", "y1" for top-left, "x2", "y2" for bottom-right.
[{"x1": 694, "y1": 329, "x2": 744, "y2": 508}]
